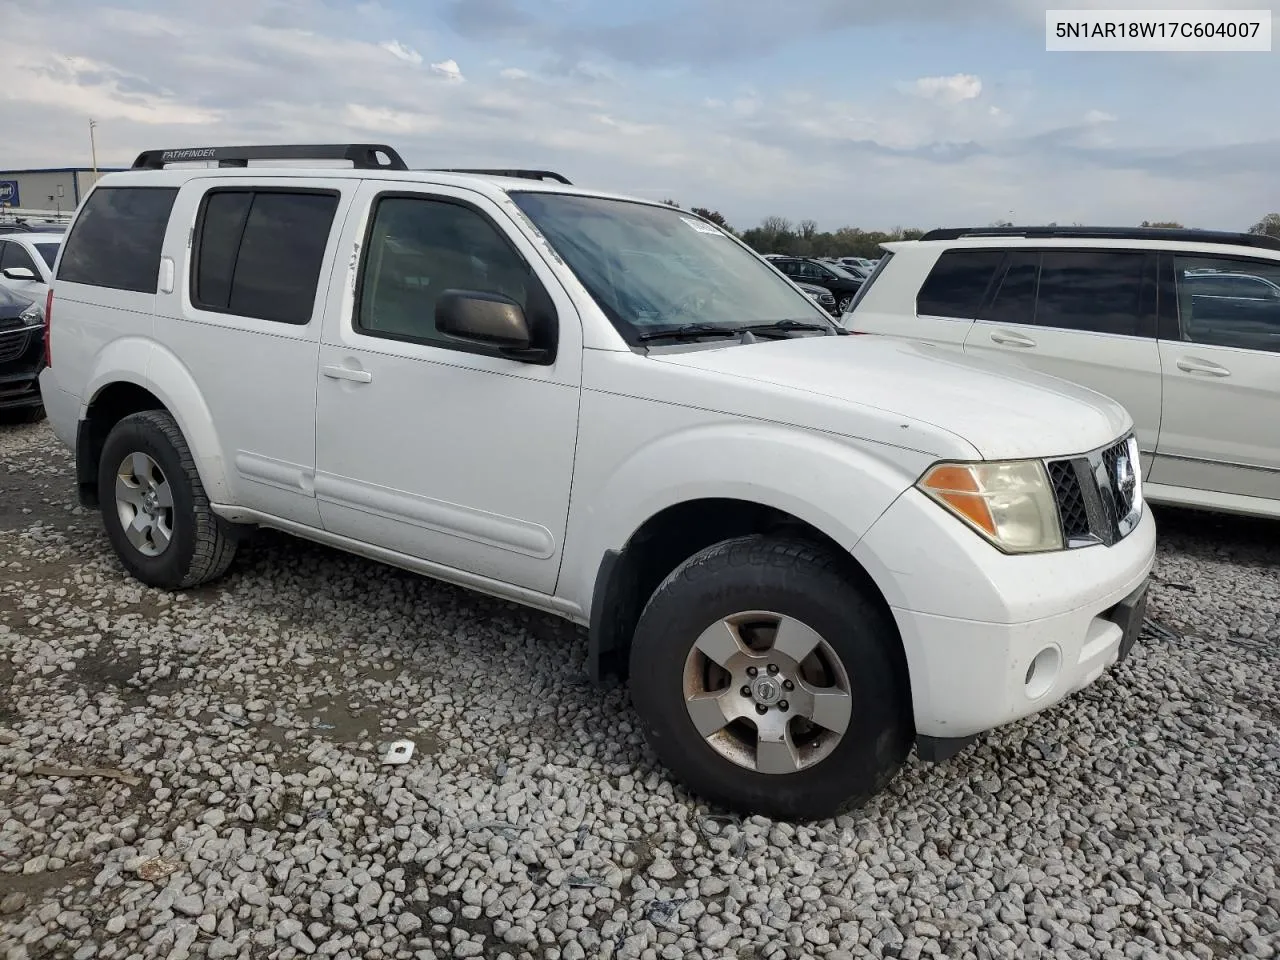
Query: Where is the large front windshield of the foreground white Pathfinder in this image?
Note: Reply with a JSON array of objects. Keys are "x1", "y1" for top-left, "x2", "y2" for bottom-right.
[{"x1": 511, "y1": 191, "x2": 832, "y2": 343}]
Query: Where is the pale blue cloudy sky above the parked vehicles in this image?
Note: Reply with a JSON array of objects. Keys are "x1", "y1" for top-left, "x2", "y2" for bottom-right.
[{"x1": 0, "y1": 0, "x2": 1280, "y2": 230}]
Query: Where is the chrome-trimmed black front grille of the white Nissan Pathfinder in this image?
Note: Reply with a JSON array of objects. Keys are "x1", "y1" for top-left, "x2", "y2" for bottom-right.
[{"x1": 1044, "y1": 436, "x2": 1140, "y2": 548}]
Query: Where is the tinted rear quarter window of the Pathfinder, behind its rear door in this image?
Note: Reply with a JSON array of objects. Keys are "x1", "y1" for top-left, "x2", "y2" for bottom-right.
[{"x1": 58, "y1": 187, "x2": 178, "y2": 293}]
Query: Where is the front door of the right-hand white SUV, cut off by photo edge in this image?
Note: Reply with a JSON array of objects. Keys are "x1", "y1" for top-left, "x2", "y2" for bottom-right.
[{"x1": 1153, "y1": 255, "x2": 1280, "y2": 500}]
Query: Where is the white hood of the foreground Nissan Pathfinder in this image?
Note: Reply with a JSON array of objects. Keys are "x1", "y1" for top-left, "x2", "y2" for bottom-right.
[{"x1": 650, "y1": 337, "x2": 1133, "y2": 460}]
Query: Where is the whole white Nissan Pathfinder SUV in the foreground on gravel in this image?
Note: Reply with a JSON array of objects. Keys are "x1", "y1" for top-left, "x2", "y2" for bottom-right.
[{"x1": 41, "y1": 145, "x2": 1156, "y2": 819}]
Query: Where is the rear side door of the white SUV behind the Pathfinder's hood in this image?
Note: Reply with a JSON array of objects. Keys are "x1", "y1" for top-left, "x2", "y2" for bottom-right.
[{"x1": 964, "y1": 247, "x2": 1161, "y2": 471}]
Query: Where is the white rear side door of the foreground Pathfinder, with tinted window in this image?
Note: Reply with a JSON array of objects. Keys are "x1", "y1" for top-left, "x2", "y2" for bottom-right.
[{"x1": 156, "y1": 174, "x2": 361, "y2": 527}]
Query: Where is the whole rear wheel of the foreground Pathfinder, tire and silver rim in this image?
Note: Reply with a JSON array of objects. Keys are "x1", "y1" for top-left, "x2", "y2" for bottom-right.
[{"x1": 97, "y1": 410, "x2": 237, "y2": 590}]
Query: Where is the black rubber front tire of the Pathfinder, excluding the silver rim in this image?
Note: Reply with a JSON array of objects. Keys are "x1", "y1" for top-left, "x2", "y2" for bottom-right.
[{"x1": 631, "y1": 537, "x2": 911, "y2": 820}]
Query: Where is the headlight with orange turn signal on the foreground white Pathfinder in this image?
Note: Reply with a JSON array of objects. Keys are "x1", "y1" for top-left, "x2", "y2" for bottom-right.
[{"x1": 916, "y1": 460, "x2": 1062, "y2": 553}]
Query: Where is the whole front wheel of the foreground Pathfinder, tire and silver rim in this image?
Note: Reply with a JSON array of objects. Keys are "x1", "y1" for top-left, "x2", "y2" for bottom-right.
[{"x1": 631, "y1": 536, "x2": 914, "y2": 820}]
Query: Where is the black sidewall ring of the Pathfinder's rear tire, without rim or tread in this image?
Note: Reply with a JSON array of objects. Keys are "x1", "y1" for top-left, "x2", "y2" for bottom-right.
[{"x1": 97, "y1": 415, "x2": 196, "y2": 589}]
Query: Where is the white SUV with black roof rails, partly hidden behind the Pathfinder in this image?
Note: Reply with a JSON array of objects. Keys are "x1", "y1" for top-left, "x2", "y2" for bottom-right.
[{"x1": 842, "y1": 228, "x2": 1280, "y2": 517}]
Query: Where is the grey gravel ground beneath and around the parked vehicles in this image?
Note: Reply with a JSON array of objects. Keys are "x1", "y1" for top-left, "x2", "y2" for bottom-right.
[{"x1": 0, "y1": 425, "x2": 1280, "y2": 960}]
